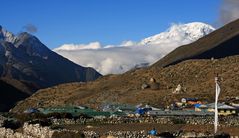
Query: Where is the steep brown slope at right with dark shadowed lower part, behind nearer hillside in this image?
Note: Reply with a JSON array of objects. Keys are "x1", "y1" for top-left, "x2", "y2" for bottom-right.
[{"x1": 154, "y1": 20, "x2": 239, "y2": 67}]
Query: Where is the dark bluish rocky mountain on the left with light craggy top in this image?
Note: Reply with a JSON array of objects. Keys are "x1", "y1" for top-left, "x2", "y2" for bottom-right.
[{"x1": 0, "y1": 27, "x2": 101, "y2": 92}]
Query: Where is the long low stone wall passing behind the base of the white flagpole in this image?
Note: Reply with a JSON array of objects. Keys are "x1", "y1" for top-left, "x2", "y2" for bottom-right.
[{"x1": 52, "y1": 116, "x2": 239, "y2": 126}]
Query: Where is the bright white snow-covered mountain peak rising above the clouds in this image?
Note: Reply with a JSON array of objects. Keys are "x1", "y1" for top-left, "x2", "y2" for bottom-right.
[{"x1": 140, "y1": 22, "x2": 215, "y2": 45}]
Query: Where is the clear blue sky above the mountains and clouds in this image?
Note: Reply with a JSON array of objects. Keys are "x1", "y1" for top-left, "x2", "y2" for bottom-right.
[{"x1": 0, "y1": 0, "x2": 221, "y2": 48}]
